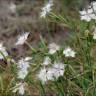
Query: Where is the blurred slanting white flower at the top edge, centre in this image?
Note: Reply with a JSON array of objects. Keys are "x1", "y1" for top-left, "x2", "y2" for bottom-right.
[{"x1": 40, "y1": 0, "x2": 53, "y2": 18}]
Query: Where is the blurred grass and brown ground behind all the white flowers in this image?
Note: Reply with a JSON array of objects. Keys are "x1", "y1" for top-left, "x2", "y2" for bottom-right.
[{"x1": 0, "y1": 0, "x2": 96, "y2": 96}]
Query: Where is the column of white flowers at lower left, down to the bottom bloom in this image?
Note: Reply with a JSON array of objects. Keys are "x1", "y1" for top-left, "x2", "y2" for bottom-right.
[{"x1": 12, "y1": 57, "x2": 32, "y2": 95}]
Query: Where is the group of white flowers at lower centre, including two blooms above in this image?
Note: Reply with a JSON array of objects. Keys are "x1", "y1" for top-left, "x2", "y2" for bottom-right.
[{"x1": 37, "y1": 43, "x2": 76, "y2": 83}]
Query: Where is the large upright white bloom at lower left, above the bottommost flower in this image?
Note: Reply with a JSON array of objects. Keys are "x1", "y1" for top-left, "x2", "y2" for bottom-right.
[{"x1": 17, "y1": 58, "x2": 30, "y2": 79}]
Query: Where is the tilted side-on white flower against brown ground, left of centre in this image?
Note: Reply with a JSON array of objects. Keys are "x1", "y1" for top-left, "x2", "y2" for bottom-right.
[{"x1": 15, "y1": 32, "x2": 29, "y2": 45}]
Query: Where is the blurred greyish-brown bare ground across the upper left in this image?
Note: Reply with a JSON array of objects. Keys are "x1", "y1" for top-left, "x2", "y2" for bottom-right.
[{"x1": 0, "y1": 0, "x2": 76, "y2": 58}]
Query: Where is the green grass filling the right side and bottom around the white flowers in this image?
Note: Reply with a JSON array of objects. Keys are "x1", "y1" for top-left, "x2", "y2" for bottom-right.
[{"x1": 0, "y1": 0, "x2": 96, "y2": 96}]
